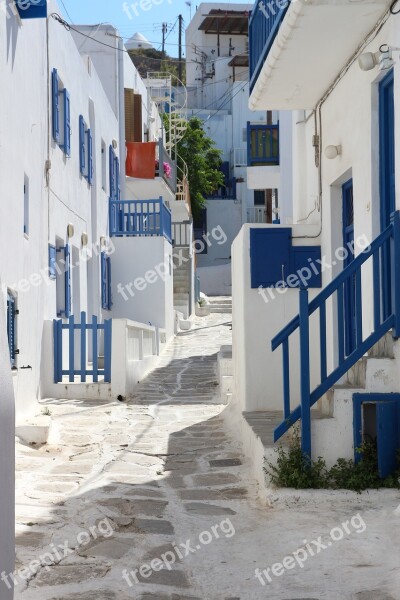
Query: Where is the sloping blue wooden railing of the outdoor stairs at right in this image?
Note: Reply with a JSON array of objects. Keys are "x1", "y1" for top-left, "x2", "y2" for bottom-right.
[{"x1": 272, "y1": 212, "x2": 400, "y2": 456}]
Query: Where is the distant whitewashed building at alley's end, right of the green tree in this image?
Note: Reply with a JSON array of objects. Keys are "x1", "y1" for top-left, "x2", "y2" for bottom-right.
[{"x1": 186, "y1": 2, "x2": 292, "y2": 295}]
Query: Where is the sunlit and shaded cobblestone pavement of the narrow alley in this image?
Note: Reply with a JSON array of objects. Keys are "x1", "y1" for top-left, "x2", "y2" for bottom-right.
[{"x1": 14, "y1": 314, "x2": 400, "y2": 600}]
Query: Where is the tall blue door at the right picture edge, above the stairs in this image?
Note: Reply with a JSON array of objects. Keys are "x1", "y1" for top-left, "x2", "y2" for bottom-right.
[{"x1": 379, "y1": 70, "x2": 396, "y2": 319}]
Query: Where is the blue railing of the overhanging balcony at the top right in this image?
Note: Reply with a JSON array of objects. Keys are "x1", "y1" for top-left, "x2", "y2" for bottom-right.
[{"x1": 249, "y1": 0, "x2": 290, "y2": 91}]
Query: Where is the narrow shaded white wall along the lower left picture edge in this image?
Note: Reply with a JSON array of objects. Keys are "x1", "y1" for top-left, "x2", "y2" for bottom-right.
[{"x1": 0, "y1": 284, "x2": 15, "y2": 600}]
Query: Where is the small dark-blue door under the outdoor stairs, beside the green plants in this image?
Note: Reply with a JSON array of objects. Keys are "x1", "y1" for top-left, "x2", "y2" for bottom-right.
[{"x1": 376, "y1": 401, "x2": 400, "y2": 478}]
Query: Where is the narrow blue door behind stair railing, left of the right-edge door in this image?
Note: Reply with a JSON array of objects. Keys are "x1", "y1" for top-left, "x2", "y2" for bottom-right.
[{"x1": 343, "y1": 179, "x2": 357, "y2": 356}]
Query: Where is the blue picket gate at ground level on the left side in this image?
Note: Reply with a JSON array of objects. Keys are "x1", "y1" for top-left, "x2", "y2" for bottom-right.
[{"x1": 53, "y1": 312, "x2": 112, "y2": 383}]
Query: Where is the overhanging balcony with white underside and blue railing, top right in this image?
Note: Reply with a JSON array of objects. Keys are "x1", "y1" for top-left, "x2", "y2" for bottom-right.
[{"x1": 249, "y1": 0, "x2": 391, "y2": 110}]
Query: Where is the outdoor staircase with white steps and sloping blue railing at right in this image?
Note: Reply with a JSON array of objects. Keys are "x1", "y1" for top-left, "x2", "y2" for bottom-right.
[{"x1": 272, "y1": 211, "x2": 400, "y2": 463}]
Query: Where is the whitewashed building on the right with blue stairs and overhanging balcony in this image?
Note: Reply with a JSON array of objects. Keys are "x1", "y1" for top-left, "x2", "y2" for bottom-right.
[{"x1": 233, "y1": 0, "x2": 400, "y2": 478}]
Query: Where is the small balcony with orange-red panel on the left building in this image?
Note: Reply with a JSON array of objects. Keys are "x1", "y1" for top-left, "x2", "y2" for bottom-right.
[{"x1": 126, "y1": 139, "x2": 177, "y2": 202}]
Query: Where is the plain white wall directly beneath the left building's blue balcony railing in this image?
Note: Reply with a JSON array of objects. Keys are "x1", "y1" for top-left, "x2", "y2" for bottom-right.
[{"x1": 110, "y1": 237, "x2": 174, "y2": 339}]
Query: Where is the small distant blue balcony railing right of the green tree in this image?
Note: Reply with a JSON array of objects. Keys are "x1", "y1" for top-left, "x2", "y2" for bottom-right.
[{"x1": 247, "y1": 123, "x2": 279, "y2": 167}]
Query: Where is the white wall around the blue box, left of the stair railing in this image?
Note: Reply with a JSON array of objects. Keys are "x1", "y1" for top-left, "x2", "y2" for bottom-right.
[{"x1": 232, "y1": 225, "x2": 320, "y2": 411}]
